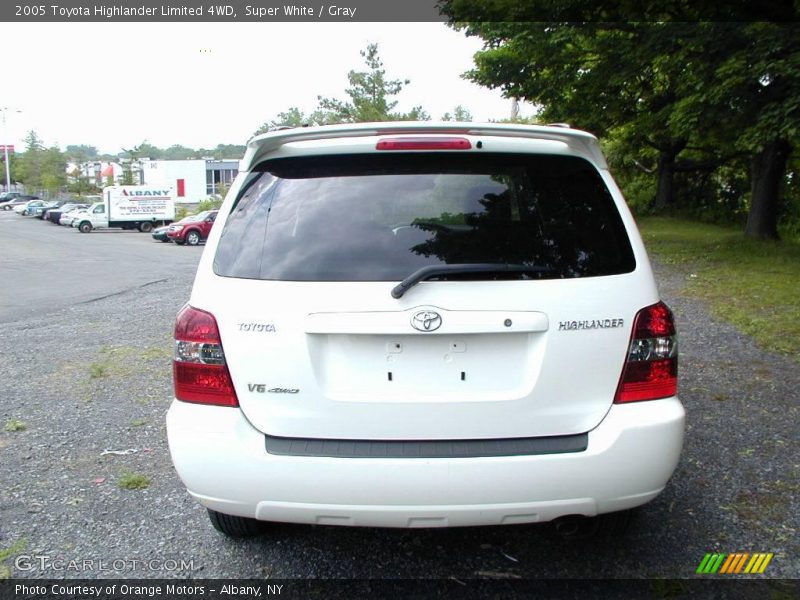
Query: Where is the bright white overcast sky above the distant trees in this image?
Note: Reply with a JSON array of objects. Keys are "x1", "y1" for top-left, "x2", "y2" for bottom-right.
[{"x1": 0, "y1": 23, "x2": 532, "y2": 153}]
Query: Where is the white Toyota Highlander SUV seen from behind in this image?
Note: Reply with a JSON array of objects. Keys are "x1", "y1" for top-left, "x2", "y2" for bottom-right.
[{"x1": 167, "y1": 122, "x2": 684, "y2": 536}]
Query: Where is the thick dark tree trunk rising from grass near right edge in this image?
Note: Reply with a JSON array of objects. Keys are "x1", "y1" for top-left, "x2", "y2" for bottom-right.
[{"x1": 744, "y1": 139, "x2": 792, "y2": 240}]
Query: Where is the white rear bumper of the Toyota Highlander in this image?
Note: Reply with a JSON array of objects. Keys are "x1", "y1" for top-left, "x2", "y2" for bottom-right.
[{"x1": 167, "y1": 398, "x2": 684, "y2": 527}]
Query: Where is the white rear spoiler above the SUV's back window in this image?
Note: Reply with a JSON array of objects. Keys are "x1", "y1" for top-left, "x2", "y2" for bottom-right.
[{"x1": 239, "y1": 121, "x2": 608, "y2": 172}]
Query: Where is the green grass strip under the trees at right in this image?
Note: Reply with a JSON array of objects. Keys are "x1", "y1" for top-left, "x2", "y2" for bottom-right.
[{"x1": 639, "y1": 217, "x2": 800, "y2": 361}]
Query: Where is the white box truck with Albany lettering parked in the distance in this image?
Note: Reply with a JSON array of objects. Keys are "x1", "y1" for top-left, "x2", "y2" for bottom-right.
[{"x1": 72, "y1": 185, "x2": 175, "y2": 233}]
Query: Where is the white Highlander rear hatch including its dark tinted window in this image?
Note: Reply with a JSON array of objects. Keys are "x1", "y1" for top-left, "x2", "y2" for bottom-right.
[{"x1": 192, "y1": 142, "x2": 655, "y2": 440}]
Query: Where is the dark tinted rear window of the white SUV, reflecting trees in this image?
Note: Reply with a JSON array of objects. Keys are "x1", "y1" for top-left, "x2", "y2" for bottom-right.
[{"x1": 214, "y1": 153, "x2": 635, "y2": 281}]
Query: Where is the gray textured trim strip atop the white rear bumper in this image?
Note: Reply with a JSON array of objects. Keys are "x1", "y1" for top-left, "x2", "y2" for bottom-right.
[{"x1": 265, "y1": 433, "x2": 589, "y2": 458}]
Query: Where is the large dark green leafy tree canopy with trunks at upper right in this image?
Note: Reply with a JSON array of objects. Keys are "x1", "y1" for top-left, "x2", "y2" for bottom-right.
[{"x1": 444, "y1": 5, "x2": 800, "y2": 238}]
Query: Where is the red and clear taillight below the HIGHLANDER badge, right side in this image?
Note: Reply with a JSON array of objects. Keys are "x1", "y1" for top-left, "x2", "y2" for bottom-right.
[{"x1": 614, "y1": 302, "x2": 678, "y2": 403}]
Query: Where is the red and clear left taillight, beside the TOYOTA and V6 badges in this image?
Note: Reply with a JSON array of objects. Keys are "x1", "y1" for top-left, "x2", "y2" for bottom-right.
[{"x1": 172, "y1": 304, "x2": 239, "y2": 406}]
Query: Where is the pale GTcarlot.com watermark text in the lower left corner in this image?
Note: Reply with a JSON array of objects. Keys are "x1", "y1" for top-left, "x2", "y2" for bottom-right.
[{"x1": 14, "y1": 554, "x2": 197, "y2": 573}]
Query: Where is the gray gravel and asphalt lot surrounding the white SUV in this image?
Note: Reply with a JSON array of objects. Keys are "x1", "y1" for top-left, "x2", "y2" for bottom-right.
[{"x1": 0, "y1": 215, "x2": 800, "y2": 579}]
